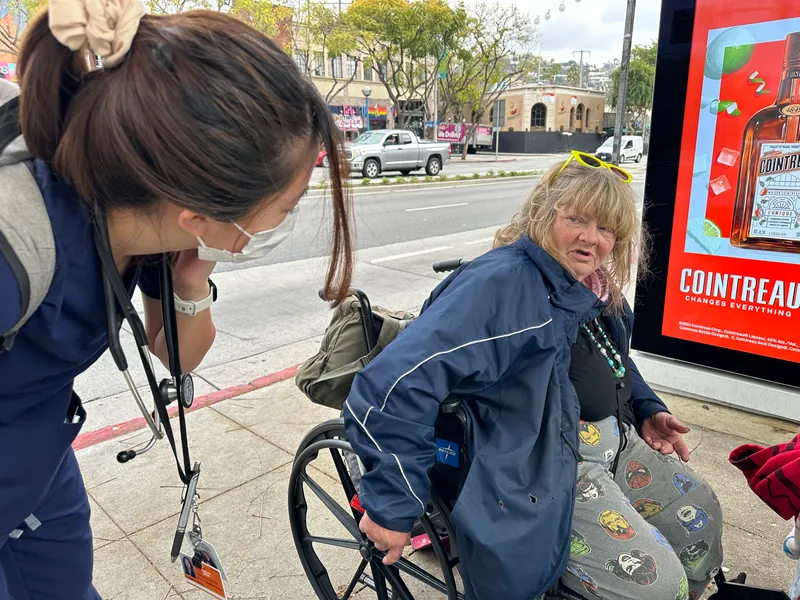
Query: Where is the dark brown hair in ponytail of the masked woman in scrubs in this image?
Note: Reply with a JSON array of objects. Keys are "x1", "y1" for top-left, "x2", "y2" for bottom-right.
[{"x1": 17, "y1": 11, "x2": 353, "y2": 301}]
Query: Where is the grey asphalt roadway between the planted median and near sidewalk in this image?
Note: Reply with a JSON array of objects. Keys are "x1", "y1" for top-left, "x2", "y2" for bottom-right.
[{"x1": 215, "y1": 168, "x2": 644, "y2": 272}]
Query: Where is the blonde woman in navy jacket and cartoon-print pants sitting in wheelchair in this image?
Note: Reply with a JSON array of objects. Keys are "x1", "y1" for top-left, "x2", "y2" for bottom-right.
[{"x1": 344, "y1": 152, "x2": 722, "y2": 600}]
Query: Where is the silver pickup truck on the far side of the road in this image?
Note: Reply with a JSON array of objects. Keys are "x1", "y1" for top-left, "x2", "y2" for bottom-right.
[{"x1": 347, "y1": 129, "x2": 450, "y2": 179}]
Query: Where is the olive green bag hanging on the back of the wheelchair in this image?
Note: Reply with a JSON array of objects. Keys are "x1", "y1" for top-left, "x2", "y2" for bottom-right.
[{"x1": 295, "y1": 290, "x2": 414, "y2": 410}]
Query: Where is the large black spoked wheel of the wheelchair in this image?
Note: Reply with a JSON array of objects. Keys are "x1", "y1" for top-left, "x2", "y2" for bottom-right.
[{"x1": 289, "y1": 419, "x2": 463, "y2": 600}]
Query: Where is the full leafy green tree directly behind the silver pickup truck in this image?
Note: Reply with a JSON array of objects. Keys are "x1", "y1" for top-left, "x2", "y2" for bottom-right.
[{"x1": 345, "y1": 0, "x2": 467, "y2": 127}]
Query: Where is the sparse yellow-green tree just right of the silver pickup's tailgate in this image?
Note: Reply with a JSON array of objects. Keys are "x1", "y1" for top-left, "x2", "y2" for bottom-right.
[{"x1": 442, "y1": 1, "x2": 536, "y2": 160}]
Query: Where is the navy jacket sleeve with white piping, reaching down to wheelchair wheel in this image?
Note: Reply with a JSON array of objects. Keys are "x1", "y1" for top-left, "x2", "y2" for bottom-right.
[{"x1": 344, "y1": 260, "x2": 550, "y2": 532}]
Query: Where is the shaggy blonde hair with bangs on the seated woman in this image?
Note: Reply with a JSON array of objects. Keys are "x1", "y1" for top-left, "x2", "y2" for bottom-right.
[{"x1": 494, "y1": 161, "x2": 647, "y2": 310}]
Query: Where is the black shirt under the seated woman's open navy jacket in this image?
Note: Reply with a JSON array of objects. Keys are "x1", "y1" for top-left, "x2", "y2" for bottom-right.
[{"x1": 569, "y1": 321, "x2": 633, "y2": 425}]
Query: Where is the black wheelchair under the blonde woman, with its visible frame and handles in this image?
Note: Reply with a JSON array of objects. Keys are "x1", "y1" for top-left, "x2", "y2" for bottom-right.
[{"x1": 288, "y1": 268, "x2": 790, "y2": 600}]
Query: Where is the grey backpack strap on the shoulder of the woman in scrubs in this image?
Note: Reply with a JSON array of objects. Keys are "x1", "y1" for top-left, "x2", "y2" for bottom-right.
[{"x1": 0, "y1": 80, "x2": 56, "y2": 354}]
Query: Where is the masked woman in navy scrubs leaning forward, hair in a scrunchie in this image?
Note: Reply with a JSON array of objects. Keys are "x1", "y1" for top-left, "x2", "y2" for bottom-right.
[{"x1": 0, "y1": 0, "x2": 352, "y2": 600}]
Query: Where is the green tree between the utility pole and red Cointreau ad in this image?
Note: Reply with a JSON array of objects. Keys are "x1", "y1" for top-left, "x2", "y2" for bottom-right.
[{"x1": 608, "y1": 42, "x2": 658, "y2": 133}]
